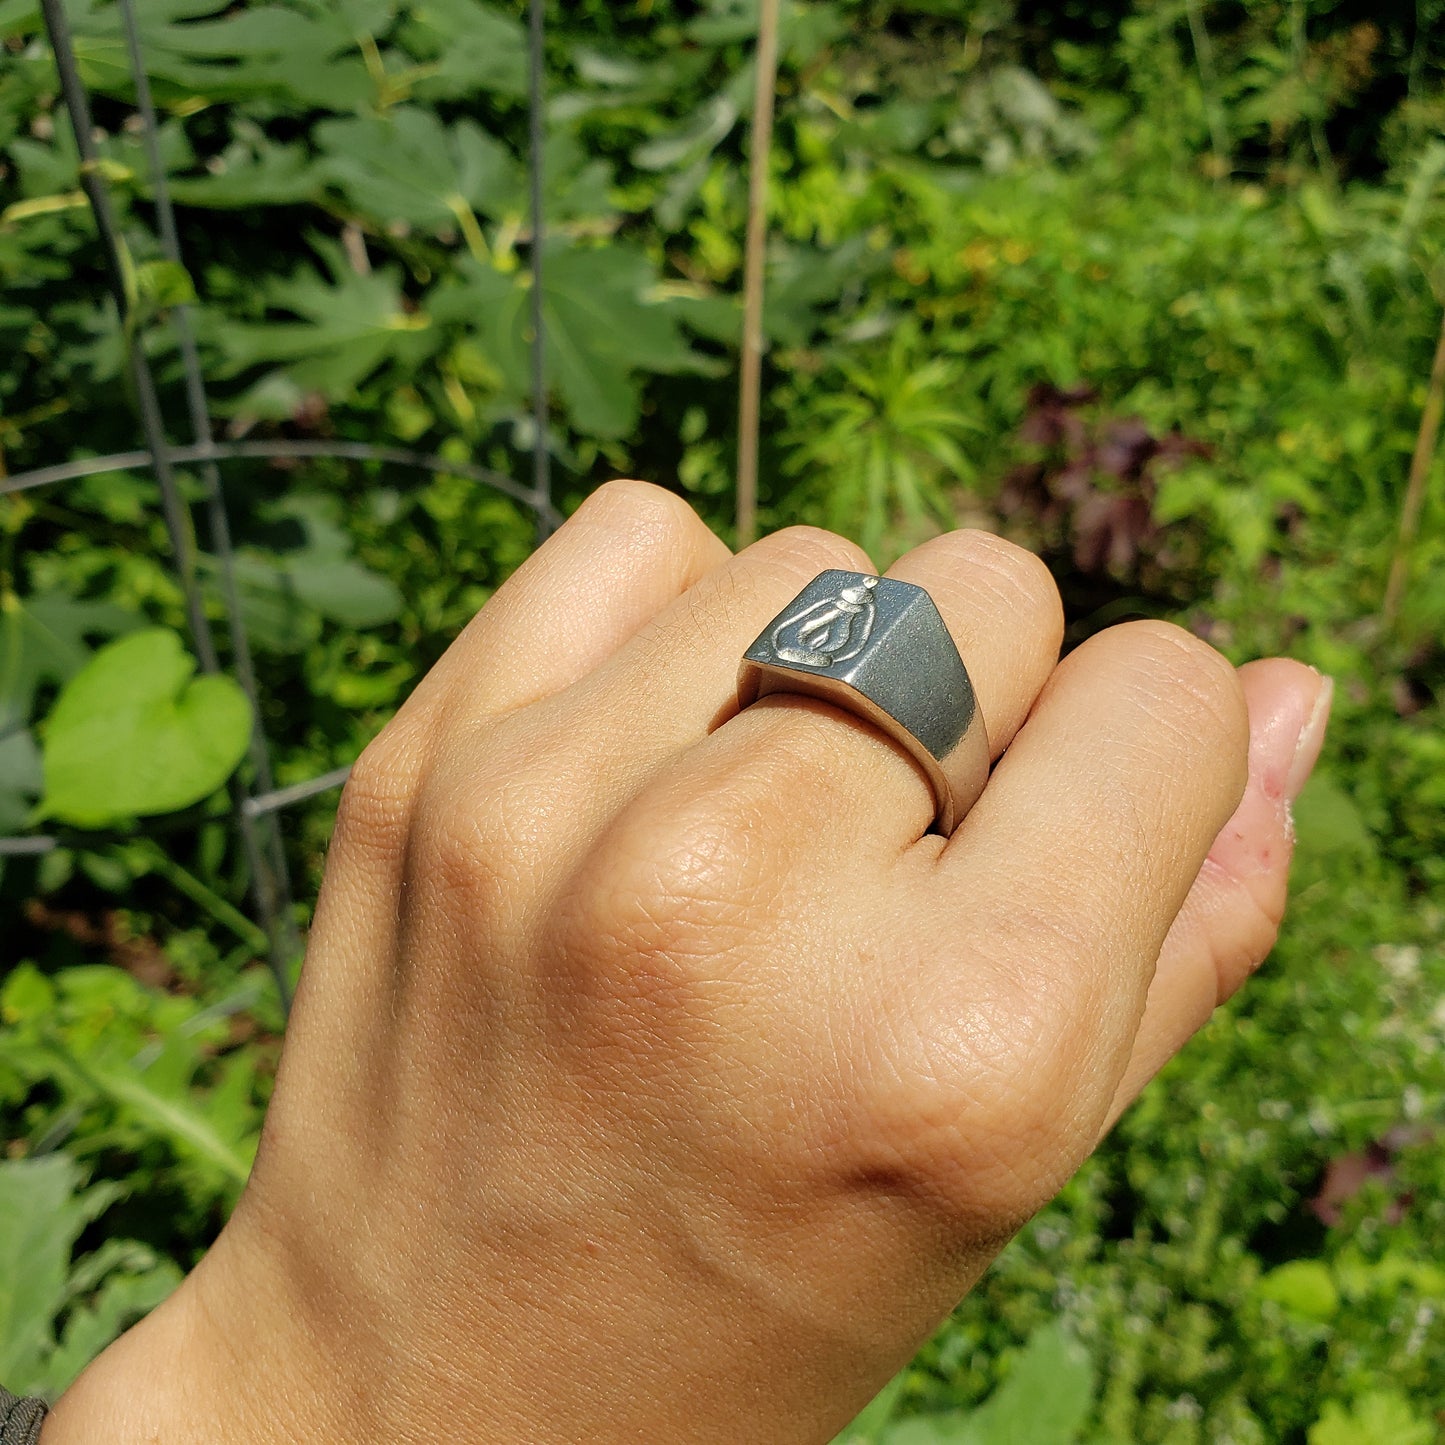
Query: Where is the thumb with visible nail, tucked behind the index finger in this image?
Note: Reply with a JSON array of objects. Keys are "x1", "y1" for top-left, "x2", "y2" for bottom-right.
[{"x1": 1110, "y1": 657, "x2": 1334, "y2": 1123}]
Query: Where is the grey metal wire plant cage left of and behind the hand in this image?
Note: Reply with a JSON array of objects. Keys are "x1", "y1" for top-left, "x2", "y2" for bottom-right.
[{"x1": 0, "y1": 0, "x2": 578, "y2": 1007}]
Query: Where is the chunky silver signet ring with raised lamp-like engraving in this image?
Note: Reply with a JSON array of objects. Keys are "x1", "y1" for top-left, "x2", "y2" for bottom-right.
[{"x1": 737, "y1": 569, "x2": 990, "y2": 837}]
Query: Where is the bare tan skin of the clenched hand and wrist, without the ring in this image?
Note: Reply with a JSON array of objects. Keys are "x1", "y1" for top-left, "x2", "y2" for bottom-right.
[{"x1": 42, "y1": 483, "x2": 1329, "y2": 1445}]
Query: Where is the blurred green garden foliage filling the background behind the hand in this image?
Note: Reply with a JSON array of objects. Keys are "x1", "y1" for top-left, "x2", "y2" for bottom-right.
[{"x1": 0, "y1": 0, "x2": 1445, "y2": 1445}]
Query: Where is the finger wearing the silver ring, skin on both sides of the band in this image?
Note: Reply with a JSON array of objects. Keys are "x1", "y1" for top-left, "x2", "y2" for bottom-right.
[{"x1": 580, "y1": 532, "x2": 1064, "y2": 877}]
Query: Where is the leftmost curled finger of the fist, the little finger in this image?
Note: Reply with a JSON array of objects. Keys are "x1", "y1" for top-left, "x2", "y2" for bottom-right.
[{"x1": 415, "y1": 481, "x2": 731, "y2": 734}]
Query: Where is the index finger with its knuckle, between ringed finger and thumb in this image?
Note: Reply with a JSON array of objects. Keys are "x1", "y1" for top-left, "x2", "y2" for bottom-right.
[{"x1": 892, "y1": 623, "x2": 1248, "y2": 1214}]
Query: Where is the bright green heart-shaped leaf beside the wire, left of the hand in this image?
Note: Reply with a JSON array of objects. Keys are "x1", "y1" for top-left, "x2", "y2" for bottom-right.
[{"x1": 39, "y1": 629, "x2": 251, "y2": 828}]
